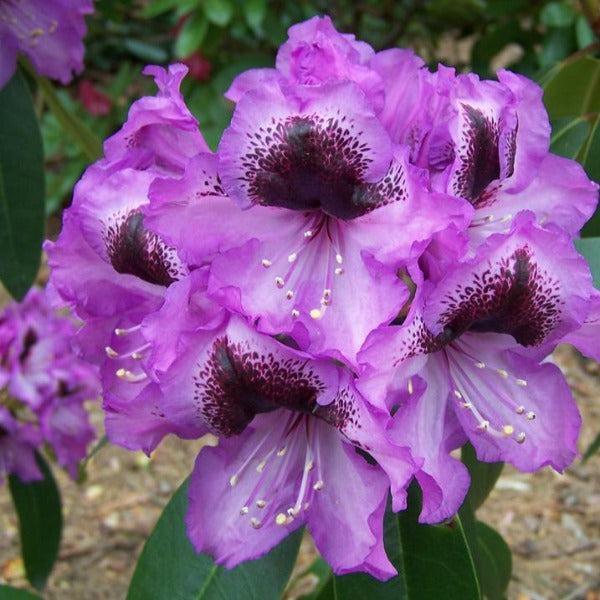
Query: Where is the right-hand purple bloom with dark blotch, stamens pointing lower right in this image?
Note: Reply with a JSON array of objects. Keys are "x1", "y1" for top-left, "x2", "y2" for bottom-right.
[{"x1": 359, "y1": 214, "x2": 594, "y2": 521}]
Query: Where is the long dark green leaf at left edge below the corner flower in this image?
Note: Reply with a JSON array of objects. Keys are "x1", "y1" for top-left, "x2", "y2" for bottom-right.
[{"x1": 0, "y1": 72, "x2": 44, "y2": 300}]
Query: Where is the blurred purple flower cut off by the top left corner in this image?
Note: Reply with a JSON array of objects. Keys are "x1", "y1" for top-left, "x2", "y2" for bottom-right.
[{"x1": 0, "y1": 0, "x2": 93, "y2": 88}]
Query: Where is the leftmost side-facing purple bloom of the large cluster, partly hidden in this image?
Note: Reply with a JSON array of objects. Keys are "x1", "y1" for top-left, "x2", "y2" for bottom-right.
[{"x1": 45, "y1": 65, "x2": 208, "y2": 452}]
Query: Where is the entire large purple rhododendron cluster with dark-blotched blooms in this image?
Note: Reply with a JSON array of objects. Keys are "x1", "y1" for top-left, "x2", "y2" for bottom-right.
[{"x1": 46, "y1": 18, "x2": 600, "y2": 579}]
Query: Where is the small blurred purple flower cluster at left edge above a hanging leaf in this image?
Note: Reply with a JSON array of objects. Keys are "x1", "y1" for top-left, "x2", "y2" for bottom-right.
[{"x1": 0, "y1": 288, "x2": 100, "y2": 483}]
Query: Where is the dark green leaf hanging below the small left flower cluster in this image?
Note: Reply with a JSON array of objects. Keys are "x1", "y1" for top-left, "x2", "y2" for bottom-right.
[{"x1": 8, "y1": 453, "x2": 62, "y2": 590}]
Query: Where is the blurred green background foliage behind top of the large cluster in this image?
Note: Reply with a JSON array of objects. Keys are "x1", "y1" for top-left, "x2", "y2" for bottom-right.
[{"x1": 42, "y1": 0, "x2": 600, "y2": 229}]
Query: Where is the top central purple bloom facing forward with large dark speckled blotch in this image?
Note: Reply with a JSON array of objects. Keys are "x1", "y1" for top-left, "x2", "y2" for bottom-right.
[{"x1": 148, "y1": 82, "x2": 471, "y2": 363}]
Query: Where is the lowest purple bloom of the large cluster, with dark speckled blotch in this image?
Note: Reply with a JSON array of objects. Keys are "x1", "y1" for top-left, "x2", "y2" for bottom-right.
[{"x1": 138, "y1": 272, "x2": 414, "y2": 579}]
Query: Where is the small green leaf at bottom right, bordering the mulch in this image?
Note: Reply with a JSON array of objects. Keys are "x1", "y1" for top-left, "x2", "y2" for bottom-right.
[{"x1": 475, "y1": 521, "x2": 512, "y2": 600}]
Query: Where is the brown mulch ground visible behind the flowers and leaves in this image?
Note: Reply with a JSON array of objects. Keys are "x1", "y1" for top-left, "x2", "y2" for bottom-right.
[{"x1": 0, "y1": 349, "x2": 600, "y2": 600}]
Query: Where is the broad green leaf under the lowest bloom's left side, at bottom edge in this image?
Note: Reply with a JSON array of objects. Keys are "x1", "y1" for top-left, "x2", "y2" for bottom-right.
[{"x1": 127, "y1": 481, "x2": 302, "y2": 600}]
